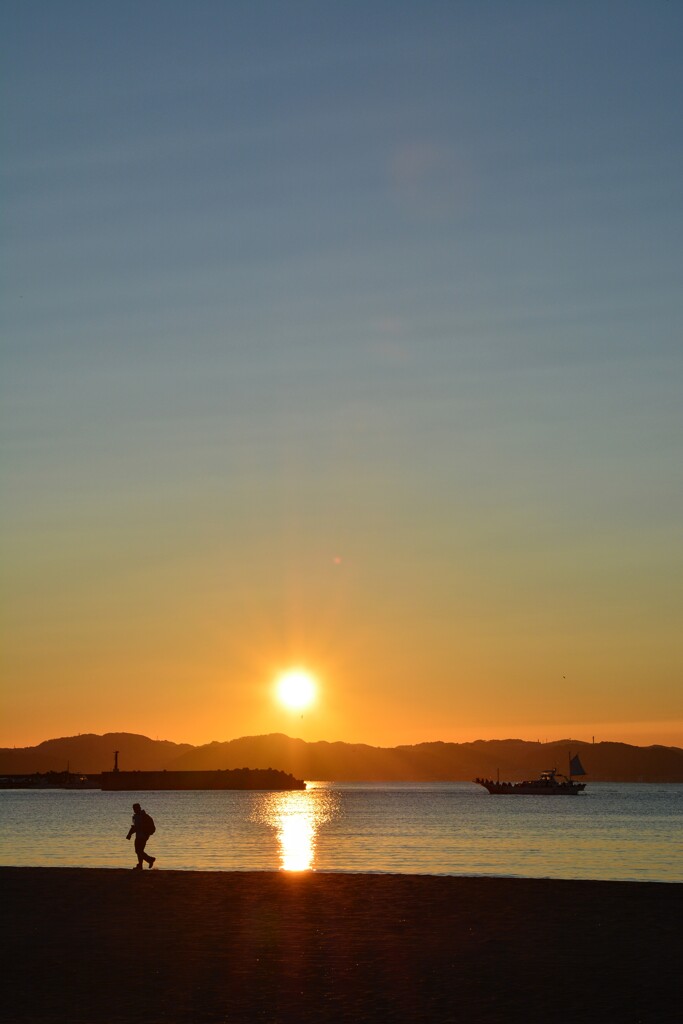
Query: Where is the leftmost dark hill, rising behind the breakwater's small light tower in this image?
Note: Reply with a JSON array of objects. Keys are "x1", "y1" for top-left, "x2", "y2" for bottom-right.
[{"x1": 0, "y1": 732, "x2": 193, "y2": 773}]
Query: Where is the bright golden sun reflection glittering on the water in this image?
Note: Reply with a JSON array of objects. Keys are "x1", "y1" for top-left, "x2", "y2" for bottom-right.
[{"x1": 262, "y1": 792, "x2": 337, "y2": 871}]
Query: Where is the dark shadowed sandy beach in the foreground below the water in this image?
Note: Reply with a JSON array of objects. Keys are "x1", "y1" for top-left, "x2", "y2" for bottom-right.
[{"x1": 0, "y1": 867, "x2": 683, "y2": 1024}]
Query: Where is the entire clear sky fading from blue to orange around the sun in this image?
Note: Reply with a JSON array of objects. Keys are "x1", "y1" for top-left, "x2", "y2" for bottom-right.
[{"x1": 0, "y1": 0, "x2": 683, "y2": 745}]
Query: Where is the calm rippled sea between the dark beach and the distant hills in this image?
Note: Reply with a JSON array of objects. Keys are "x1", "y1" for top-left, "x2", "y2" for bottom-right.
[{"x1": 0, "y1": 782, "x2": 683, "y2": 882}]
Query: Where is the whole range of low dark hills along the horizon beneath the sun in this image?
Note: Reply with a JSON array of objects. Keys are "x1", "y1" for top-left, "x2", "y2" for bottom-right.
[{"x1": 0, "y1": 732, "x2": 683, "y2": 782}]
